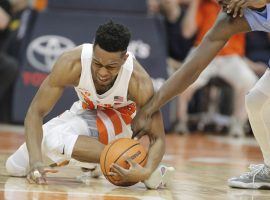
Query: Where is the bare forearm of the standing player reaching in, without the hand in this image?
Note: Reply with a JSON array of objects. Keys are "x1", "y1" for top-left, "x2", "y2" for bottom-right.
[{"x1": 150, "y1": 33, "x2": 227, "y2": 113}]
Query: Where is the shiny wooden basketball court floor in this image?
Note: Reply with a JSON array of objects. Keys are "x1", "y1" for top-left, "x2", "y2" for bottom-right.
[{"x1": 0, "y1": 126, "x2": 270, "y2": 200}]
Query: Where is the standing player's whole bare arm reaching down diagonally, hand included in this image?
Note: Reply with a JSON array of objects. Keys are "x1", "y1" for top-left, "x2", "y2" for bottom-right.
[{"x1": 132, "y1": 12, "x2": 250, "y2": 137}]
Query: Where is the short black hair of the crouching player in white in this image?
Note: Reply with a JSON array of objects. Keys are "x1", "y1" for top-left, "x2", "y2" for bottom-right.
[{"x1": 94, "y1": 20, "x2": 131, "y2": 52}]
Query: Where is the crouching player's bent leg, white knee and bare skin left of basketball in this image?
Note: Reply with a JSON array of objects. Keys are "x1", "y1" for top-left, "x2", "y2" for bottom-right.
[{"x1": 43, "y1": 110, "x2": 104, "y2": 163}]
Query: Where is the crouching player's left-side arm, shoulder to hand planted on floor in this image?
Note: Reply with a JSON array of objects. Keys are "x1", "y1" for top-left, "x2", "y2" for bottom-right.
[{"x1": 24, "y1": 47, "x2": 80, "y2": 184}]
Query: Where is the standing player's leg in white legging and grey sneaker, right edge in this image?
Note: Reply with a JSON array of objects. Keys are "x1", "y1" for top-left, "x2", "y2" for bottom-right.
[{"x1": 228, "y1": 70, "x2": 270, "y2": 189}]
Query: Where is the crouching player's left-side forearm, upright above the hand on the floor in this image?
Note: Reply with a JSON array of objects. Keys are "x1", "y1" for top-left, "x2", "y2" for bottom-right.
[{"x1": 25, "y1": 111, "x2": 43, "y2": 165}]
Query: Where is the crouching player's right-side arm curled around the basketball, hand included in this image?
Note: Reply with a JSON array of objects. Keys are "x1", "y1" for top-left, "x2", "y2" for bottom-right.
[{"x1": 110, "y1": 60, "x2": 165, "y2": 182}]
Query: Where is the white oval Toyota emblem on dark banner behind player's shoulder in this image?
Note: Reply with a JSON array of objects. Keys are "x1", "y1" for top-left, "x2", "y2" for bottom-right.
[{"x1": 27, "y1": 35, "x2": 75, "y2": 72}]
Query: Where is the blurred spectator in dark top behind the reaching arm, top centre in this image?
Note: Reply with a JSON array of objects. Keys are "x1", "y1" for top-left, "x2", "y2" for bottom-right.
[{"x1": 148, "y1": 0, "x2": 199, "y2": 130}]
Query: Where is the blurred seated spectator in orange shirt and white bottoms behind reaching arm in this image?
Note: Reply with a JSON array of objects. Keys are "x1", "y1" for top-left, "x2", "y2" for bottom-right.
[{"x1": 177, "y1": 0, "x2": 257, "y2": 136}]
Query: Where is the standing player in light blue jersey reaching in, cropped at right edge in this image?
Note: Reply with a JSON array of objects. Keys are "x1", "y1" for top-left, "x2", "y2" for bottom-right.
[{"x1": 132, "y1": 0, "x2": 270, "y2": 189}]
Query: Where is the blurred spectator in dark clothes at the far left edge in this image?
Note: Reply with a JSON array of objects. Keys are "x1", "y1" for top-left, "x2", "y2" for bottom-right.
[{"x1": 0, "y1": 0, "x2": 18, "y2": 120}]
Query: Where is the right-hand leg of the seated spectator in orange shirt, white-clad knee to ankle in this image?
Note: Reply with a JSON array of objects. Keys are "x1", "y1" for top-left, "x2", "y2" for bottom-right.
[{"x1": 216, "y1": 55, "x2": 258, "y2": 136}]
